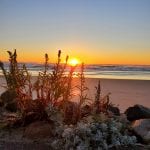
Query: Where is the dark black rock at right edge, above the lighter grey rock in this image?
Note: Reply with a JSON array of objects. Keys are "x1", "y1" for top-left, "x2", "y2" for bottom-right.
[{"x1": 125, "y1": 105, "x2": 150, "y2": 121}]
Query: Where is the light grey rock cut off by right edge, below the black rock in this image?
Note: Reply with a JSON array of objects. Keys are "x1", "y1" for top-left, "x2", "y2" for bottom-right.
[{"x1": 132, "y1": 119, "x2": 150, "y2": 144}]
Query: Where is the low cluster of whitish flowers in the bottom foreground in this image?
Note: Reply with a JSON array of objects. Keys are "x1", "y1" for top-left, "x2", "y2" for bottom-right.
[{"x1": 52, "y1": 119, "x2": 136, "y2": 150}]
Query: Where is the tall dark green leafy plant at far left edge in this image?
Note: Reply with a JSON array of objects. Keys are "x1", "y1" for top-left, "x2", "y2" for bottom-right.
[{"x1": 0, "y1": 49, "x2": 32, "y2": 111}]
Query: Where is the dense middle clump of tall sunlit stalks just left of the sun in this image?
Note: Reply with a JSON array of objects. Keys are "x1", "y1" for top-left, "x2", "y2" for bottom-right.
[{"x1": 34, "y1": 50, "x2": 75, "y2": 124}]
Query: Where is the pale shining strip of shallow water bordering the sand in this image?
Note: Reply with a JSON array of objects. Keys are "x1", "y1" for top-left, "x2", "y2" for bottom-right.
[{"x1": 0, "y1": 68, "x2": 150, "y2": 80}]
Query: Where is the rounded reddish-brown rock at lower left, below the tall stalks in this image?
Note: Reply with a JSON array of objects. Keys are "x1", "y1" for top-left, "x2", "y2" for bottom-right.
[{"x1": 23, "y1": 121, "x2": 54, "y2": 139}]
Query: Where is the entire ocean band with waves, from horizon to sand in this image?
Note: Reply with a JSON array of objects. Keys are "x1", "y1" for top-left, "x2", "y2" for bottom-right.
[{"x1": 0, "y1": 63, "x2": 150, "y2": 80}]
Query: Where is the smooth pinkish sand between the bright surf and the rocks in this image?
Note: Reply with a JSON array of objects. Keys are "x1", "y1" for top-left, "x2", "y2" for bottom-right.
[{"x1": 0, "y1": 76, "x2": 150, "y2": 112}]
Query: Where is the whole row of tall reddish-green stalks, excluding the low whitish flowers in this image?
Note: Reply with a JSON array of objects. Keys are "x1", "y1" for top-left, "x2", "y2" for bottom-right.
[{"x1": 0, "y1": 50, "x2": 116, "y2": 124}]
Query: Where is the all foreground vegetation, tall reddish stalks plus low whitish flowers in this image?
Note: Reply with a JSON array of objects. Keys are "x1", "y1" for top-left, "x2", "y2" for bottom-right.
[{"x1": 0, "y1": 50, "x2": 139, "y2": 150}]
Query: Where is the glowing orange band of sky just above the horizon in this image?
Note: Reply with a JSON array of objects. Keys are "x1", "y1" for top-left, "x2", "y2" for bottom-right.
[{"x1": 0, "y1": 47, "x2": 150, "y2": 65}]
